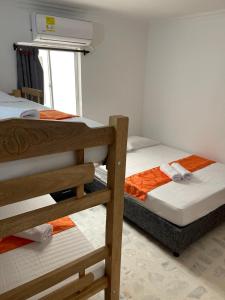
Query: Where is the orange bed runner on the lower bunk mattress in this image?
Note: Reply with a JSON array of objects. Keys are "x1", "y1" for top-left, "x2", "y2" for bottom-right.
[{"x1": 0, "y1": 217, "x2": 76, "y2": 254}]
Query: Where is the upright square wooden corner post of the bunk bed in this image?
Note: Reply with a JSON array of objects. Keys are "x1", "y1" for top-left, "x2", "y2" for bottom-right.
[{"x1": 105, "y1": 116, "x2": 128, "y2": 300}]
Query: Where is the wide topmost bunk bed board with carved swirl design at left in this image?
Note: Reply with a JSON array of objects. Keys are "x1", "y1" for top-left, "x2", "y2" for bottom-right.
[{"x1": 0, "y1": 119, "x2": 114, "y2": 162}]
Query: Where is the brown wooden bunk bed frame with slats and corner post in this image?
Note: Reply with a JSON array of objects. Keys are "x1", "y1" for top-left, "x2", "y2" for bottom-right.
[{"x1": 0, "y1": 116, "x2": 128, "y2": 300}]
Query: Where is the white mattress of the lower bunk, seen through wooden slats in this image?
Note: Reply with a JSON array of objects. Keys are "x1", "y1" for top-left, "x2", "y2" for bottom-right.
[{"x1": 0, "y1": 196, "x2": 104, "y2": 299}]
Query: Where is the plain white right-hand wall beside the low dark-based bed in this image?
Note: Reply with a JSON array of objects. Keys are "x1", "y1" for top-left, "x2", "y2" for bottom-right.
[{"x1": 142, "y1": 13, "x2": 225, "y2": 162}]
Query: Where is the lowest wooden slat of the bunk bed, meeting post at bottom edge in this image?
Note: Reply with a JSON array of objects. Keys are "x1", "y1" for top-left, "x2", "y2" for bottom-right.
[{"x1": 66, "y1": 276, "x2": 108, "y2": 300}]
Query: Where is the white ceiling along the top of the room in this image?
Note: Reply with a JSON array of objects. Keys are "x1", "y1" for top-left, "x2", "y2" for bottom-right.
[{"x1": 42, "y1": 0, "x2": 225, "y2": 20}]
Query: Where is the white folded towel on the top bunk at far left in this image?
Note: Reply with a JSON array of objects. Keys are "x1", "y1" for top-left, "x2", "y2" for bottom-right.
[{"x1": 0, "y1": 104, "x2": 40, "y2": 119}]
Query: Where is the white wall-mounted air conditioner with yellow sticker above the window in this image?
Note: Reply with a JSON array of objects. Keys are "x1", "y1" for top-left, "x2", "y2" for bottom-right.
[{"x1": 32, "y1": 14, "x2": 93, "y2": 46}]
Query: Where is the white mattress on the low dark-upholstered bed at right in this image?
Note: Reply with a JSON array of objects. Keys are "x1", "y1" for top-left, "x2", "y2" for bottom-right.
[{"x1": 96, "y1": 145, "x2": 225, "y2": 226}]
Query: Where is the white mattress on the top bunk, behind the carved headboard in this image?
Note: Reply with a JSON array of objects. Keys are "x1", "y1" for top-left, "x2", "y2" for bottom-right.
[{"x1": 0, "y1": 92, "x2": 107, "y2": 180}]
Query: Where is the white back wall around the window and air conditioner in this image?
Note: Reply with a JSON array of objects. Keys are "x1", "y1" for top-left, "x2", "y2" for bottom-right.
[{"x1": 0, "y1": 0, "x2": 148, "y2": 134}]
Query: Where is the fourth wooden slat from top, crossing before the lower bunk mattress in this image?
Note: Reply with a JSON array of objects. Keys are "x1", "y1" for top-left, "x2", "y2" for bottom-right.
[{"x1": 0, "y1": 247, "x2": 109, "y2": 300}]
